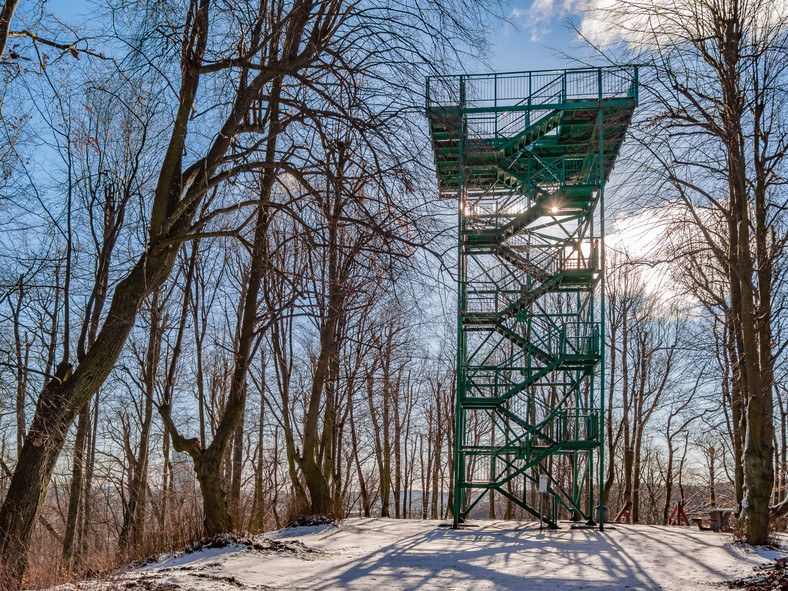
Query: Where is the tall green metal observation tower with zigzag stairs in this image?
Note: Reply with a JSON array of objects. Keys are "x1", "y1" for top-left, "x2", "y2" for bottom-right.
[{"x1": 427, "y1": 67, "x2": 638, "y2": 529}]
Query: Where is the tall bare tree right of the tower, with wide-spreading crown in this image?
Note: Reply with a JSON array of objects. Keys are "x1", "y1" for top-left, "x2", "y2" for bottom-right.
[{"x1": 598, "y1": 0, "x2": 788, "y2": 544}]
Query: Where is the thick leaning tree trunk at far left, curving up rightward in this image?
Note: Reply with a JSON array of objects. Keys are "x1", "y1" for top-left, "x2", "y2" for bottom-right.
[{"x1": 0, "y1": 0, "x2": 215, "y2": 589}]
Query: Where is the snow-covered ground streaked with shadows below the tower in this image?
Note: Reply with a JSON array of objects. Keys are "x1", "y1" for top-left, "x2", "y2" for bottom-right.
[{"x1": 52, "y1": 518, "x2": 781, "y2": 591}]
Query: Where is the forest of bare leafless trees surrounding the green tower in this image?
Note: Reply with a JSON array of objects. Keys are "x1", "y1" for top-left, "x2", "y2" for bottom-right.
[{"x1": 0, "y1": 0, "x2": 788, "y2": 589}]
